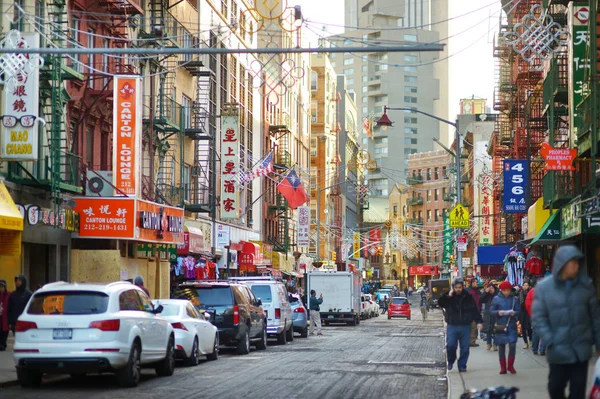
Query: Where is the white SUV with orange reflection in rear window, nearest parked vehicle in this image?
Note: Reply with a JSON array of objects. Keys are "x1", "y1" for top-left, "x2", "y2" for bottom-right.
[{"x1": 13, "y1": 282, "x2": 175, "y2": 387}]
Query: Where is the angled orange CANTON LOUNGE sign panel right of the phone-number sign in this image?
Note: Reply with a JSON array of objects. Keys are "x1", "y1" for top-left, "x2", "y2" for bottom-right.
[{"x1": 136, "y1": 200, "x2": 184, "y2": 244}]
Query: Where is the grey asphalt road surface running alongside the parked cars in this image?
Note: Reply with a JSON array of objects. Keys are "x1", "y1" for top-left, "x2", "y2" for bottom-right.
[{"x1": 0, "y1": 299, "x2": 447, "y2": 399}]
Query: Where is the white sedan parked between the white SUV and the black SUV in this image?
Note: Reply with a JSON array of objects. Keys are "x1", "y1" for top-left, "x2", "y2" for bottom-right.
[{"x1": 152, "y1": 299, "x2": 219, "y2": 366}]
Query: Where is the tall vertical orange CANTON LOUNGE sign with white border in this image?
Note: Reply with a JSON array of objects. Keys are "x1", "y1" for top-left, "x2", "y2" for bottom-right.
[{"x1": 113, "y1": 76, "x2": 142, "y2": 196}]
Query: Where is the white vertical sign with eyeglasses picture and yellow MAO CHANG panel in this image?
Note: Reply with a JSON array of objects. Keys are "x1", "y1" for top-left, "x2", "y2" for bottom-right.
[{"x1": 0, "y1": 33, "x2": 40, "y2": 161}]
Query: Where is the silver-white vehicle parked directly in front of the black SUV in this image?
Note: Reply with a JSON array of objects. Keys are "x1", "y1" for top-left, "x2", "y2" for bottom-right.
[{"x1": 230, "y1": 276, "x2": 294, "y2": 344}]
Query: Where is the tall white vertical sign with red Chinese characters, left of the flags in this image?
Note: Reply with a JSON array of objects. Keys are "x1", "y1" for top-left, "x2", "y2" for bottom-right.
[{"x1": 221, "y1": 115, "x2": 240, "y2": 220}]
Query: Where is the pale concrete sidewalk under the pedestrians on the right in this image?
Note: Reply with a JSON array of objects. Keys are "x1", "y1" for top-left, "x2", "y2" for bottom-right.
[{"x1": 447, "y1": 339, "x2": 596, "y2": 399}]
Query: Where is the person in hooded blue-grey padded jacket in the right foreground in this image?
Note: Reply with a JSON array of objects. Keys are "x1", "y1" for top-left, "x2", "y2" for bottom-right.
[{"x1": 532, "y1": 245, "x2": 600, "y2": 399}]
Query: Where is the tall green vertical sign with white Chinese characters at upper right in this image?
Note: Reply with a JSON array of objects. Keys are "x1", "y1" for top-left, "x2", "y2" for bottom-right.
[{"x1": 569, "y1": 2, "x2": 595, "y2": 152}]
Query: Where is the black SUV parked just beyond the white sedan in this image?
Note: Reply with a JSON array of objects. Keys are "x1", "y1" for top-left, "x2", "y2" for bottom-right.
[{"x1": 173, "y1": 281, "x2": 267, "y2": 355}]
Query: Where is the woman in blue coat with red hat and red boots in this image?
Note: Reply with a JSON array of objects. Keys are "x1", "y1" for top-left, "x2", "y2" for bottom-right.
[{"x1": 490, "y1": 281, "x2": 521, "y2": 374}]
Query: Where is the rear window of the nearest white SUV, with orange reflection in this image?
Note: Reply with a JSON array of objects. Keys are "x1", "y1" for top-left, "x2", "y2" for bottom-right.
[{"x1": 27, "y1": 291, "x2": 108, "y2": 315}]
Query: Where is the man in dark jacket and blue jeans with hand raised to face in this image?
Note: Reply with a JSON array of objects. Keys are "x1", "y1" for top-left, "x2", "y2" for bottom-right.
[{"x1": 438, "y1": 278, "x2": 483, "y2": 373}]
